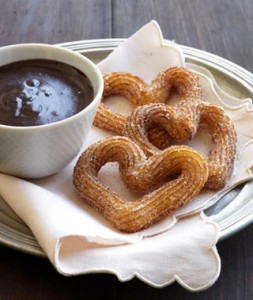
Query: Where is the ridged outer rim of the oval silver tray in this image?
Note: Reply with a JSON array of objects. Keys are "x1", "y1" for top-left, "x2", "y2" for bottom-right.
[{"x1": 0, "y1": 38, "x2": 253, "y2": 257}]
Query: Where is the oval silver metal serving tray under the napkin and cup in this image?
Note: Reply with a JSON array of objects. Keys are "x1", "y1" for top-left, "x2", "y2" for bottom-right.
[{"x1": 0, "y1": 39, "x2": 253, "y2": 256}]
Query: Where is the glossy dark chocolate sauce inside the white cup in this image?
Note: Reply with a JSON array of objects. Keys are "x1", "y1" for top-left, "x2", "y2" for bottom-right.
[{"x1": 0, "y1": 59, "x2": 94, "y2": 126}]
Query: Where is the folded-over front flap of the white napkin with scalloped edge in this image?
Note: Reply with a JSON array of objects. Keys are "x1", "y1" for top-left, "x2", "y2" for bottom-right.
[{"x1": 55, "y1": 213, "x2": 221, "y2": 291}]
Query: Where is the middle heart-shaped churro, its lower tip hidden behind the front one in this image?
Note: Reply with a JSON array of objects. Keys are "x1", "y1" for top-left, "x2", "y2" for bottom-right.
[{"x1": 124, "y1": 99, "x2": 236, "y2": 189}]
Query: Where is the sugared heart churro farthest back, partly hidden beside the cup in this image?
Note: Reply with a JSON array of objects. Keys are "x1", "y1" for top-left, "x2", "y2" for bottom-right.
[{"x1": 94, "y1": 67, "x2": 201, "y2": 135}]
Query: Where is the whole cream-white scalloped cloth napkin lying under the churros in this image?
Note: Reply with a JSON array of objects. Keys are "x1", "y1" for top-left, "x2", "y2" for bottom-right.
[{"x1": 0, "y1": 21, "x2": 253, "y2": 291}]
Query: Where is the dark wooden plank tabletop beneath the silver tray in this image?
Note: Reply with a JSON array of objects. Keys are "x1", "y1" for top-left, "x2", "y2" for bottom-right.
[{"x1": 0, "y1": 0, "x2": 253, "y2": 300}]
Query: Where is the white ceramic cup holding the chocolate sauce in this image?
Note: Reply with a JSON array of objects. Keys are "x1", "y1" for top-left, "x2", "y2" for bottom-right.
[{"x1": 0, "y1": 44, "x2": 103, "y2": 178}]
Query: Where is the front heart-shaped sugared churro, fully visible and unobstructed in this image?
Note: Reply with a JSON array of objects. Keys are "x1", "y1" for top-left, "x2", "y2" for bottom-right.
[{"x1": 73, "y1": 136, "x2": 208, "y2": 233}]
